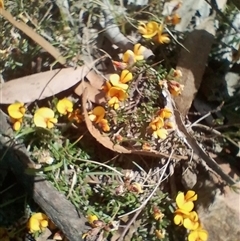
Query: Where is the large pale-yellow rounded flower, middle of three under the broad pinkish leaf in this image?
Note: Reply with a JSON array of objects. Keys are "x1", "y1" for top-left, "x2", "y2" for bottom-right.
[{"x1": 33, "y1": 107, "x2": 57, "y2": 129}]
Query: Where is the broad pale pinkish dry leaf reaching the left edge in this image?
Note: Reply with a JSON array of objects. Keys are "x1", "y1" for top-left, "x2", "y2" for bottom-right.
[{"x1": 0, "y1": 65, "x2": 94, "y2": 104}]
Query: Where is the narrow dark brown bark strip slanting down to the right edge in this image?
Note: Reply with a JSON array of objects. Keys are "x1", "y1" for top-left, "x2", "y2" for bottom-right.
[{"x1": 174, "y1": 105, "x2": 235, "y2": 185}]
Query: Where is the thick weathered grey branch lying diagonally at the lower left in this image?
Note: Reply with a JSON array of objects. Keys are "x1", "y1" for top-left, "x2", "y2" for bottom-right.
[{"x1": 0, "y1": 111, "x2": 86, "y2": 241}]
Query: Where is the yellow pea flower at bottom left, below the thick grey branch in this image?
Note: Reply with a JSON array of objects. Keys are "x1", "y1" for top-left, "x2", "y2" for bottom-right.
[{"x1": 28, "y1": 212, "x2": 48, "y2": 233}]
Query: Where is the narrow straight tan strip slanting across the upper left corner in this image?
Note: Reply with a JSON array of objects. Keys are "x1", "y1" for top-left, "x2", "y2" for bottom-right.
[{"x1": 0, "y1": 8, "x2": 66, "y2": 65}]
